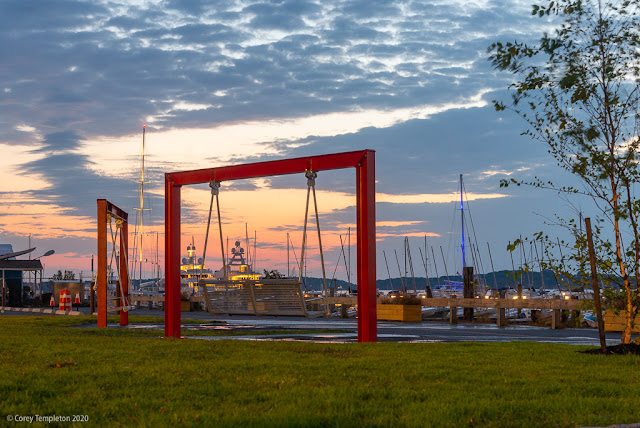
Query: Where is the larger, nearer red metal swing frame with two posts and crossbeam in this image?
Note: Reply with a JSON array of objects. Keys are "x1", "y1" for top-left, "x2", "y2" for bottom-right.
[{"x1": 164, "y1": 150, "x2": 378, "y2": 342}]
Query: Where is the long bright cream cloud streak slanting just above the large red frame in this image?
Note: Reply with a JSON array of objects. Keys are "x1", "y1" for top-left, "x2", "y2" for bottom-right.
[{"x1": 82, "y1": 89, "x2": 486, "y2": 176}]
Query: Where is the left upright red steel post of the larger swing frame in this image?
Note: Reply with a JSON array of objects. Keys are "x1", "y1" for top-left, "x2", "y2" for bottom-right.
[{"x1": 164, "y1": 174, "x2": 181, "y2": 338}]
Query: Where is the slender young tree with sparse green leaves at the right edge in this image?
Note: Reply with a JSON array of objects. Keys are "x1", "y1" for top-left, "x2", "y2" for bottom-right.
[{"x1": 489, "y1": 0, "x2": 640, "y2": 343}]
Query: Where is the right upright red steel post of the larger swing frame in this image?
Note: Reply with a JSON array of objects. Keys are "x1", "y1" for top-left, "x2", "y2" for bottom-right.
[{"x1": 356, "y1": 151, "x2": 378, "y2": 342}]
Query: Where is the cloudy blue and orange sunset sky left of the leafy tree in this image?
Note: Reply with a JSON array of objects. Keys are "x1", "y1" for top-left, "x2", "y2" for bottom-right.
[{"x1": 0, "y1": 0, "x2": 580, "y2": 278}]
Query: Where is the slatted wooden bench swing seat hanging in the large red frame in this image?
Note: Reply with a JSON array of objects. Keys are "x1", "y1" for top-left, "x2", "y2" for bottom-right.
[{"x1": 198, "y1": 278, "x2": 311, "y2": 317}]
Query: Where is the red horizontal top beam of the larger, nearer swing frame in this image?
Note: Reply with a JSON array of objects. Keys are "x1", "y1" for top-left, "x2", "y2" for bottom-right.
[{"x1": 165, "y1": 150, "x2": 372, "y2": 186}]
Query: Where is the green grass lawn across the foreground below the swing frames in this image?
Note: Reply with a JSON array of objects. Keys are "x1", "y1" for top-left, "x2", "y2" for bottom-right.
[{"x1": 0, "y1": 316, "x2": 640, "y2": 427}]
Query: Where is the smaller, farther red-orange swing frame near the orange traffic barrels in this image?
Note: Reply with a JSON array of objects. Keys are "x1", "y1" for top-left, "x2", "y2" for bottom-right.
[{"x1": 96, "y1": 199, "x2": 129, "y2": 328}]
